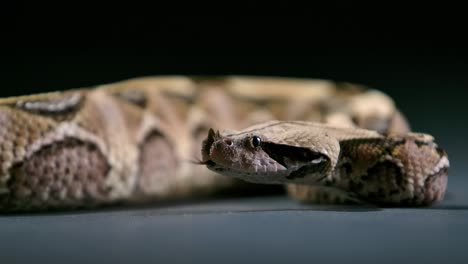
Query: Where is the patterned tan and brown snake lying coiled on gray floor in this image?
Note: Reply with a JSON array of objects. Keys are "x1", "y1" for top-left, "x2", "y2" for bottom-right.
[{"x1": 0, "y1": 75, "x2": 450, "y2": 212}]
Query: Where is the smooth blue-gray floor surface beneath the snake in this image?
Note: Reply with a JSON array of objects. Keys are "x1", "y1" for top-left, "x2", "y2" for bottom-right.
[{"x1": 0, "y1": 175, "x2": 468, "y2": 264}]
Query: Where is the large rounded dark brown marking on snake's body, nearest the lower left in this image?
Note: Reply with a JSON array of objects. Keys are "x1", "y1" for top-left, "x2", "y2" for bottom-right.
[{"x1": 0, "y1": 138, "x2": 110, "y2": 208}]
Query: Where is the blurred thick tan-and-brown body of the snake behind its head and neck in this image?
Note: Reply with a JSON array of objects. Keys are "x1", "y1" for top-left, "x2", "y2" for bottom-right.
[{"x1": 0, "y1": 76, "x2": 448, "y2": 211}]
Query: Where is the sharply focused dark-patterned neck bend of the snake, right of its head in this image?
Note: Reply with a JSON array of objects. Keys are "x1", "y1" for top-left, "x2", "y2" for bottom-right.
[{"x1": 327, "y1": 133, "x2": 449, "y2": 206}]
